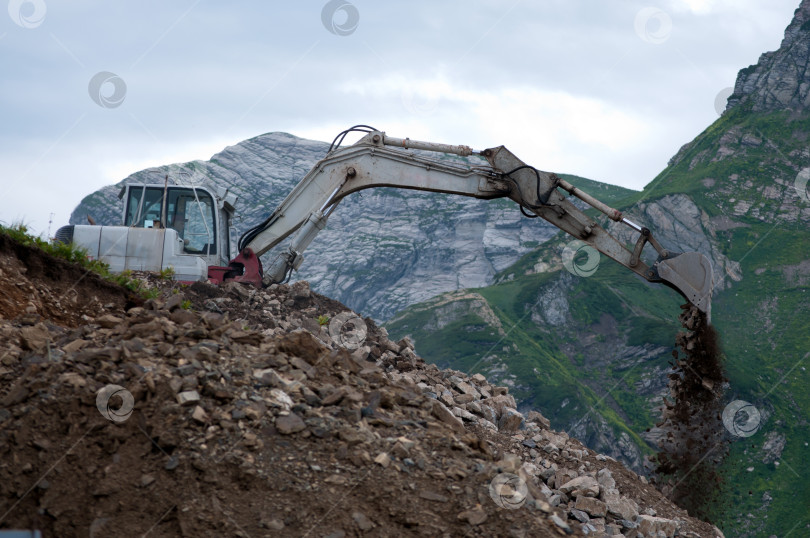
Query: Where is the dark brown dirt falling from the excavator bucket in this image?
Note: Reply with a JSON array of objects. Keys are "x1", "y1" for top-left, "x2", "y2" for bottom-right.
[{"x1": 655, "y1": 303, "x2": 728, "y2": 518}]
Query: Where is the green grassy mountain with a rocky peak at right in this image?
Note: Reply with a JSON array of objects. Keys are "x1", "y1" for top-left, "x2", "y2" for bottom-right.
[{"x1": 386, "y1": 1, "x2": 810, "y2": 536}]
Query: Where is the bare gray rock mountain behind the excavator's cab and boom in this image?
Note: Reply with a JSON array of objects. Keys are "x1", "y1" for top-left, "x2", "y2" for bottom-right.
[{"x1": 70, "y1": 133, "x2": 557, "y2": 320}]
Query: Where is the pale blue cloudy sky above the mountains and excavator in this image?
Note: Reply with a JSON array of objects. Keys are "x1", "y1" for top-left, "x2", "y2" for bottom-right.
[{"x1": 0, "y1": 0, "x2": 799, "y2": 234}]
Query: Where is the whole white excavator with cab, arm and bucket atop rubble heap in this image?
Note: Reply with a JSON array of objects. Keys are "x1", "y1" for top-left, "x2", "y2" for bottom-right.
[{"x1": 56, "y1": 125, "x2": 712, "y2": 314}]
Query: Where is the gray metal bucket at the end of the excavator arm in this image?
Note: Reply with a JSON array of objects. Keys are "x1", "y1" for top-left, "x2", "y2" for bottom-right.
[{"x1": 656, "y1": 252, "x2": 713, "y2": 316}]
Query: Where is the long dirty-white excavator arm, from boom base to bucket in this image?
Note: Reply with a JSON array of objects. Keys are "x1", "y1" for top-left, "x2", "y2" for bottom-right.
[{"x1": 209, "y1": 130, "x2": 712, "y2": 313}]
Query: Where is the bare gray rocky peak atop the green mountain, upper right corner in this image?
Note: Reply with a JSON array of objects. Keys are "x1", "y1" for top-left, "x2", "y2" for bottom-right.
[{"x1": 726, "y1": 0, "x2": 810, "y2": 112}]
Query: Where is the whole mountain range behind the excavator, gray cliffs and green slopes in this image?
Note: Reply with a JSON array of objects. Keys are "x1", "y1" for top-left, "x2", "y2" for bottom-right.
[{"x1": 71, "y1": 1, "x2": 810, "y2": 536}]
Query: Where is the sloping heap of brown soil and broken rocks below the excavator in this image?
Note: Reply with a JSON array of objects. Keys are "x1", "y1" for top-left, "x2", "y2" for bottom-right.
[{"x1": 0, "y1": 237, "x2": 721, "y2": 537}]
